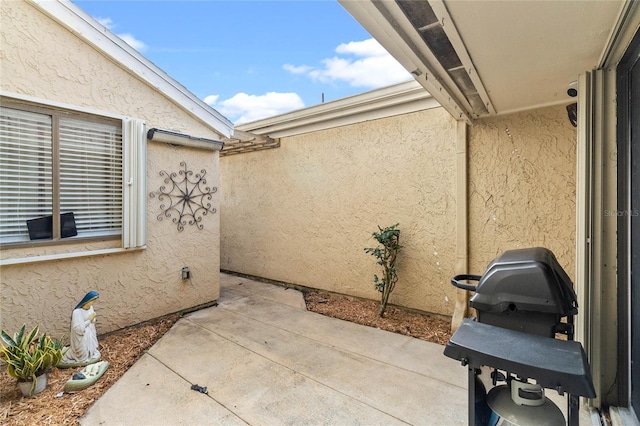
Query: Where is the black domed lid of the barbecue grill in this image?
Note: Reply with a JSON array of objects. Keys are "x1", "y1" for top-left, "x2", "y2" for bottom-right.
[{"x1": 469, "y1": 247, "x2": 578, "y2": 316}]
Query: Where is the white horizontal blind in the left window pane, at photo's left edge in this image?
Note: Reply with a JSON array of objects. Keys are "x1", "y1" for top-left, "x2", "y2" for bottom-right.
[{"x1": 0, "y1": 107, "x2": 53, "y2": 243}]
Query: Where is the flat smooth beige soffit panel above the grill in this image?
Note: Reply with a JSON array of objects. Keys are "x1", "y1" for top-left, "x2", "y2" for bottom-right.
[{"x1": 445, "y1": 0, "x2": 622, "y2": 112}]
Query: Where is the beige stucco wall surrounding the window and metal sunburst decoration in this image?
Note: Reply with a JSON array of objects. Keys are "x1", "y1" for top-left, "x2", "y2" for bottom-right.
[{"x1": 0, "y1": 1, "x2": 220, "y2": 334}]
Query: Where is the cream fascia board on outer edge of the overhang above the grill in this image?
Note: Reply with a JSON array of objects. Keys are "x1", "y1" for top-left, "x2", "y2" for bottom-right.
[{"x1": 338, "y1": 0, "x2": 473, "y2": 123}]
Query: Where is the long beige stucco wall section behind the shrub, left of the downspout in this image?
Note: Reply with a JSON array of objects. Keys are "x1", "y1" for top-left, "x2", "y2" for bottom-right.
[{"x1": 220, "y1": 108, "x2": 456, "y2": 315}]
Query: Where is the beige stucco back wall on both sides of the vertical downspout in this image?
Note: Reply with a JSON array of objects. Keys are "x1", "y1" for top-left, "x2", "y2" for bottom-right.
[{"x1": 221, "y1": 103, "x2": 576, "y2": 315}]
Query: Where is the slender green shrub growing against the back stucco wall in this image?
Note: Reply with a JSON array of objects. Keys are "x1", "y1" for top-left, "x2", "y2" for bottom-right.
[{"x1": 364, "y1": 223, "x2": 402, "y2": 317}]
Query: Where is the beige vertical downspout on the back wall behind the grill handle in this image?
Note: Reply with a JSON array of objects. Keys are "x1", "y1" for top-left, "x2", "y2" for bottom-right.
[{"x1": 451, "y1": 120, "x2": 469, "y2": 332}]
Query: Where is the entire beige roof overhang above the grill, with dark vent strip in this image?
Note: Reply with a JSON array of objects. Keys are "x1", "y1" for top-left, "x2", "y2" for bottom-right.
[{"x1": 339, "y1": 0, "x2": 638, "y2": 121}]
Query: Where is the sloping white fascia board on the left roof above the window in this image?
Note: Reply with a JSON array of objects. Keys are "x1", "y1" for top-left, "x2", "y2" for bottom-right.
[{"x1": 27, "y1": 0, "x2": 233, "y2": 137}]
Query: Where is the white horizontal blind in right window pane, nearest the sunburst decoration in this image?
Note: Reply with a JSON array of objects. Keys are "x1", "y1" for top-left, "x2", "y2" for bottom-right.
[{"x1": 59, "y1": 118, "x2": 123, "y2": 235}]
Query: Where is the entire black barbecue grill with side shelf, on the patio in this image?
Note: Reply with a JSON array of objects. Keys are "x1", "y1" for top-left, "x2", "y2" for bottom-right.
[{"x1": 444, "y1": 247, "x2": 595, "y2": 426}]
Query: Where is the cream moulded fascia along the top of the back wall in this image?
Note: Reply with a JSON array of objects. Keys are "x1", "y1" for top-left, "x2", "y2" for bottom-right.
[{"x1": 236, "y1": 81, "x2": 441, "y2": 139}]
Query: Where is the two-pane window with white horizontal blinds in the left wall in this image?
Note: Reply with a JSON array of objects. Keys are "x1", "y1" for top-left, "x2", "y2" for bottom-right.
[{"x1": 0, "y1": 101, "x2": 134, "y2": 245}]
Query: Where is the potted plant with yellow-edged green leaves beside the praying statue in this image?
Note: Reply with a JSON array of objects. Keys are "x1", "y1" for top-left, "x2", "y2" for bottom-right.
[{"x1": 0, "y1": 325, "x2": 63, "y2": 396}]
